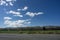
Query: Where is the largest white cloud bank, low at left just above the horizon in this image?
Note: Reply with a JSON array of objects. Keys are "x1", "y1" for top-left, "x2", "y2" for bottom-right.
[{"x1": 4, "y1": 20, "x2": 31, "y2": 27}]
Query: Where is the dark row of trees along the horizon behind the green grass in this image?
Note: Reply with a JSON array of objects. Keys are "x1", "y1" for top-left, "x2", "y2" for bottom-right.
[{"x1": 0, "y1": 26, "x2": 60, "y2": 31}]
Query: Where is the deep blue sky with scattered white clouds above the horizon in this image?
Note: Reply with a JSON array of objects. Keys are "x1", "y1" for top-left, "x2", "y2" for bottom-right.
[{"x1": 0, "y1": 0, "x2": 60, "y2": 27}]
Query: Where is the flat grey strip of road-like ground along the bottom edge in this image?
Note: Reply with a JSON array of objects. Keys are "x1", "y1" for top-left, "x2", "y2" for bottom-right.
[{"x1": 0, "y1": 34, "x2": 60, "y2": 40}]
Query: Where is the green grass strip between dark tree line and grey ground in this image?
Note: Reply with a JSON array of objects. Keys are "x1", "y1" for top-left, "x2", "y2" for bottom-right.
[{"x1": 0, "y1": 30, "x2": 60, "y2": 34}]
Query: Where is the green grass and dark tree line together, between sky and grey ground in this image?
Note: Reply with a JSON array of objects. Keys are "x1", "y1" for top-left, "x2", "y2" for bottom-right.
[{"x1": 0, "y1": 26, "x2": 60, "y2": 34}]
